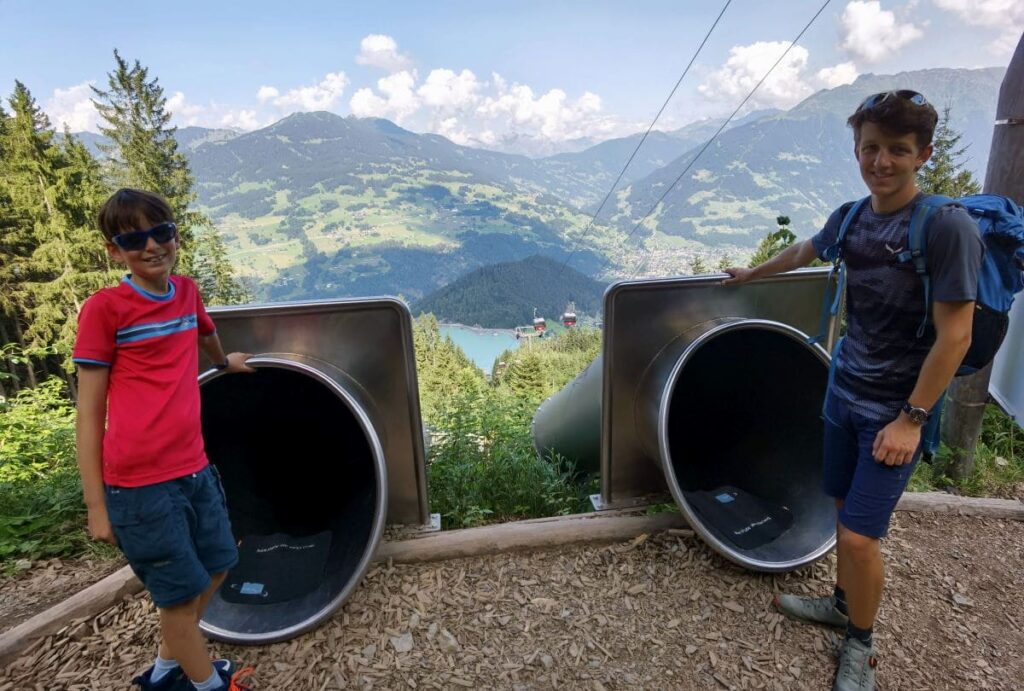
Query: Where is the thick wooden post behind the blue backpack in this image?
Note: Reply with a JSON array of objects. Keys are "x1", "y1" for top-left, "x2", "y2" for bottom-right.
[{"x1": 942, "y1": 35, "x2": 1024, "y2": 479}]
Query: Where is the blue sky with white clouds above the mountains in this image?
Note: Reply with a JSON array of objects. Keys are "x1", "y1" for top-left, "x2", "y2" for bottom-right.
[{"x1": 0, "y1": 0, "x2": 1024, "y2": 153}]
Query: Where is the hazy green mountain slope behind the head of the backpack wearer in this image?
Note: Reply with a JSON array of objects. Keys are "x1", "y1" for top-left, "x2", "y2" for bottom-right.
[{"x1": 602, "y1": 68, "x2": 1004, "y2": 253}]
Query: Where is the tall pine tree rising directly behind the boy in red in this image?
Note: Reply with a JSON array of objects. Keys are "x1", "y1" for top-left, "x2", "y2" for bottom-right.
[{"x1": 92, "y1": 50, "x2": 248, "y2": 304}]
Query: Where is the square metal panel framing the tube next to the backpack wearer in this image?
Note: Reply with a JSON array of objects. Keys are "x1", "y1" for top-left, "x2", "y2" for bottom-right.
[{"x1": 601, "y1": 268, "x2": 829, "y2": 507}]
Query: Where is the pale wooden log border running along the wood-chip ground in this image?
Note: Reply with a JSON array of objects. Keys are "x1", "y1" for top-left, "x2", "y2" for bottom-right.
[{"x1": 0, "y1": 492, "x2": 1024, "y2": 664}]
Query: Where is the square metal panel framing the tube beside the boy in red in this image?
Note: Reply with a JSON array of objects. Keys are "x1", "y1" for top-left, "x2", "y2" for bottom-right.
[{"x1": 201, "y1": 298, "x2": 430, "y2": 524}]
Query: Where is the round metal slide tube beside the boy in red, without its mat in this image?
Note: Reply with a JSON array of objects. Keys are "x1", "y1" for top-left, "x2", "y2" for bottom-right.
[{"x1": 200, "y1": 353, "x2": 388, "y2": 644}]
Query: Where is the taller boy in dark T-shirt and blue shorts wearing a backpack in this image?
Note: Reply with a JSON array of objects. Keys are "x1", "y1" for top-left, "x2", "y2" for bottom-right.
[{"x1": 723, "y1": 90, "x2": 984, "y2": 691}]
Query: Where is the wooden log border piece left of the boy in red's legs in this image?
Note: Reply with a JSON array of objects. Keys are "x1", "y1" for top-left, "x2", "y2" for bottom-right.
[{"x1": 0, "y1": 566, "x2": 142, "y2": 664}]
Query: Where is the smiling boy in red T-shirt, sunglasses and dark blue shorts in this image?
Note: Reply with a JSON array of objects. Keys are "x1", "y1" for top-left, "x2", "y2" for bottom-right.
[{"x1": 73, "y1": 189, "x2": 254, "y2": 691}]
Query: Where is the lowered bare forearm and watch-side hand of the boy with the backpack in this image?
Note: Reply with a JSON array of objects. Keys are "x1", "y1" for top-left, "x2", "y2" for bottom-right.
[{"x1": 871, "y1": 301, "x2": 974, "y2": 466}]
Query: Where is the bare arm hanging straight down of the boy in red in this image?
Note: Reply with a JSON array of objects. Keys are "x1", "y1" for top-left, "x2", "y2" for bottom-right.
[{"x1": 75, "y1": 364, "x2": 117, "y2": 545}]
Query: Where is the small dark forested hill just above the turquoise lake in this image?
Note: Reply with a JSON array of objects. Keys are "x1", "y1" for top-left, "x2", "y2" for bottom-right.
[{"x1": 412, "y1": 256, "x2": 605, "y2": 329}]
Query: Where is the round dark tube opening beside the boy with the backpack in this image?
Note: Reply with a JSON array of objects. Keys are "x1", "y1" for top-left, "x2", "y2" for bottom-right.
[{"x1": 662, "y1": 322, "x2": 835, "y2": 570}]
